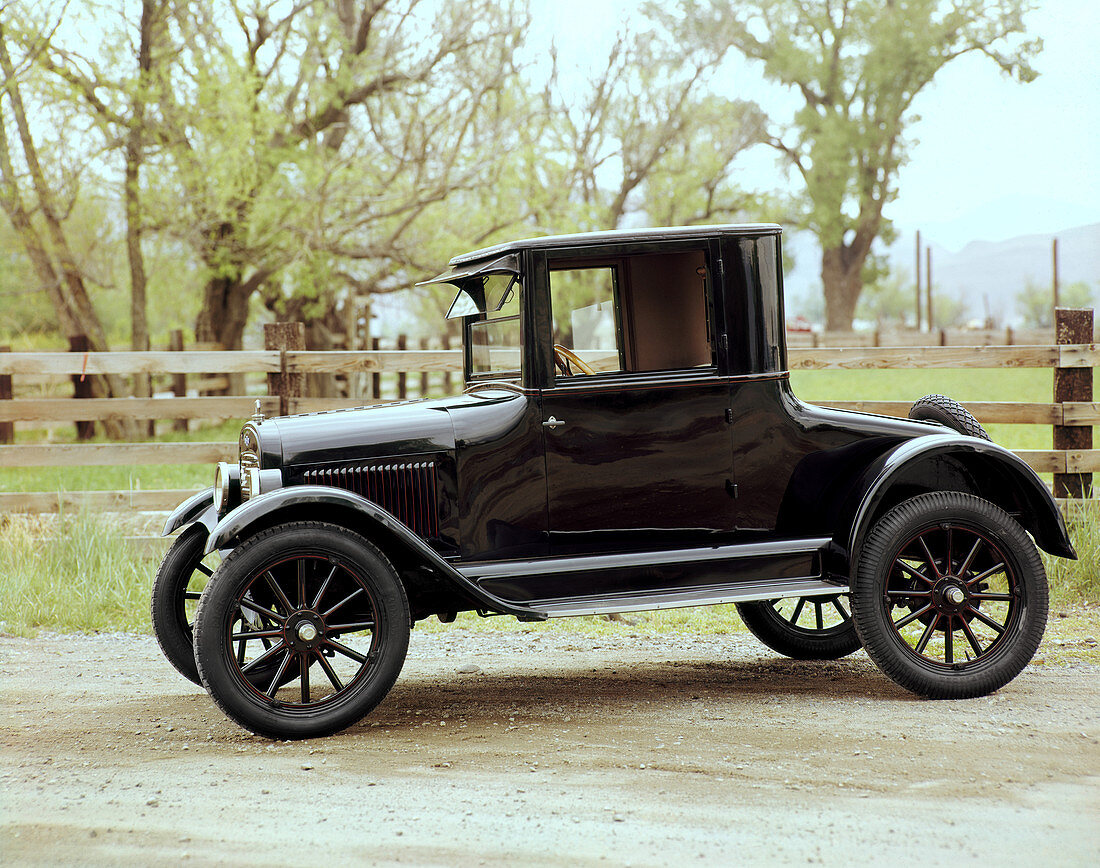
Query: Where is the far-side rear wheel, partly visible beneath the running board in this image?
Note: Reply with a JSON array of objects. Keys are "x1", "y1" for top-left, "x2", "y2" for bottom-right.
[{"x1": 737, "y1": 594, "x2": 859, "y2": 660}]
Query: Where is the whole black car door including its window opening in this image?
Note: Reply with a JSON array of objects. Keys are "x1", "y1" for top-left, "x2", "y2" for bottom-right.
[{"x1": 541, "y1": 245, "x2": 735, "y2": 567}]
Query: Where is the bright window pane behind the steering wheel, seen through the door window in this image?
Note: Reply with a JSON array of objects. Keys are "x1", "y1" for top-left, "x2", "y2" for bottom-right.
[{"x1": 550, "y1": 265, "x2": 623, "y2": 376}]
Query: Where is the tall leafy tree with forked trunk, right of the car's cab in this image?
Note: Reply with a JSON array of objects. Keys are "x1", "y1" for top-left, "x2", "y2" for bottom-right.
[{"x1": 664, "y1": 0, "x2": 1042, "y2": 330}]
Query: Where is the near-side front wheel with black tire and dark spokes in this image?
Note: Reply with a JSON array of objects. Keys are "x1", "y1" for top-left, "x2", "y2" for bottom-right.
[{"x1": 195, "y1": 521, "x2": 409, "y2": 739}]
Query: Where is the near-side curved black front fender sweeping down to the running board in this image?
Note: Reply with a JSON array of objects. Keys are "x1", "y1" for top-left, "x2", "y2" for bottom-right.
[{"x1": 206, "y1": 485, "x2": 546, "y2": 620}]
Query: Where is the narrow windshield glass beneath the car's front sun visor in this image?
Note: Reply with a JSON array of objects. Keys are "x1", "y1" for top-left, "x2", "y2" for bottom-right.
[{"x1": 460, "y1": 274, "x2": 524, "y2": 376}]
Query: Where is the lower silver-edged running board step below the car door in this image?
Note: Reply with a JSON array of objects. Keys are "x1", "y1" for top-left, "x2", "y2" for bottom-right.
[{"x1": 530, "y1": 579, "x2": 848, "y2": 618}]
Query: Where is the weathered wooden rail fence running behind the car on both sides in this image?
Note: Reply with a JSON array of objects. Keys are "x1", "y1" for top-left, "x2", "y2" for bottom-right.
[{"x1": 0, "y1": 311, "x2": 1100, "y2": 513}]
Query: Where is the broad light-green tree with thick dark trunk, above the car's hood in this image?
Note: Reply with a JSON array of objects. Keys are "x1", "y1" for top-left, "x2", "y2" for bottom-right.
[{"x1": 150, "y1": 0, "x2": 528, "y2": 347}]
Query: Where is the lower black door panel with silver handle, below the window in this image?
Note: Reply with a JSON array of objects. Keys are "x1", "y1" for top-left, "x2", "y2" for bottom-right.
[{"x1": 542, "y1": 373, "x2": 735, "y2": 556}]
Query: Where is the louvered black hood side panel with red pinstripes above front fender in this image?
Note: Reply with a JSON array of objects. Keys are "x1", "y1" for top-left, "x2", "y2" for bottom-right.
[{"x1": 303, "y1": 461, "x2": 439, "y2": 539}]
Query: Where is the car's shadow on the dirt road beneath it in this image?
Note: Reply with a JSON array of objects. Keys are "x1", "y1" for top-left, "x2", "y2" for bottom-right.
[{"x1": 118, "y1": 655, "x2": 920, "y2": 735}]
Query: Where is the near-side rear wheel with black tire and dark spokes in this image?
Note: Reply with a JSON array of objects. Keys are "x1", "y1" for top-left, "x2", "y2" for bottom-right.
[{"x1": 851, "y1": 492, "x2": 1047, "y2": 699}]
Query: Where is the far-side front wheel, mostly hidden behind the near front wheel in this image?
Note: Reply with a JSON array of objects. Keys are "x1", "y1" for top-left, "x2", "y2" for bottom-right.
[{"x1": 150, "y1": 524, "x2": 217, "y2": 684}]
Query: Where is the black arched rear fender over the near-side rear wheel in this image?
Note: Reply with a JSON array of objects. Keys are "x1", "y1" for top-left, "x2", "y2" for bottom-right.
[{"x1": 848, "y1": 433, "x2": 1077, "y2": 564}]
